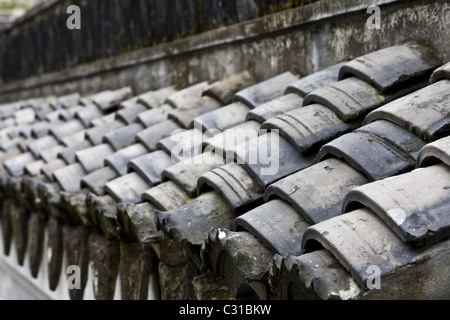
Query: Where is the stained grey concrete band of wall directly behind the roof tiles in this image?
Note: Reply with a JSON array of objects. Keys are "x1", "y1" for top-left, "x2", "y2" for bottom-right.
[{"x1": 0, "y1": 0, "x2": 450, "y2": 101}]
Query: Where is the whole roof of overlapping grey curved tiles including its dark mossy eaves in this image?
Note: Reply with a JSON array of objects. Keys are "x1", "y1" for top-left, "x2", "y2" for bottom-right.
[{"x1": 0, "y1": 43, "x2": 450, "y2": 299}]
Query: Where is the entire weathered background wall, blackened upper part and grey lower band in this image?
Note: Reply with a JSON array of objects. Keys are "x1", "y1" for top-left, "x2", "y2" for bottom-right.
[{"x1": 0, "y1": 0, "x2": 450, "y2": 101}]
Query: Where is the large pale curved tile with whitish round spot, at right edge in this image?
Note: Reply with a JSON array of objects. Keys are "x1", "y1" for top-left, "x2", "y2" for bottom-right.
[{"x1": 344, "y1": 164, "x2": 450, "y2": 245}]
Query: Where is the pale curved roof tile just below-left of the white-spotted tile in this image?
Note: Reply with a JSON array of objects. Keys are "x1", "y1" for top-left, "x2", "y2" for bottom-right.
[{"x1": 302, "y1": 208, "x2": 448, "y2": 288}]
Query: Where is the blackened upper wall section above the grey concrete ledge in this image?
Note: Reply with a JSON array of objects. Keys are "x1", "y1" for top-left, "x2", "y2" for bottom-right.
[{"x1": 0, "y1": 0, "x2": 320, "y2": 83}]
